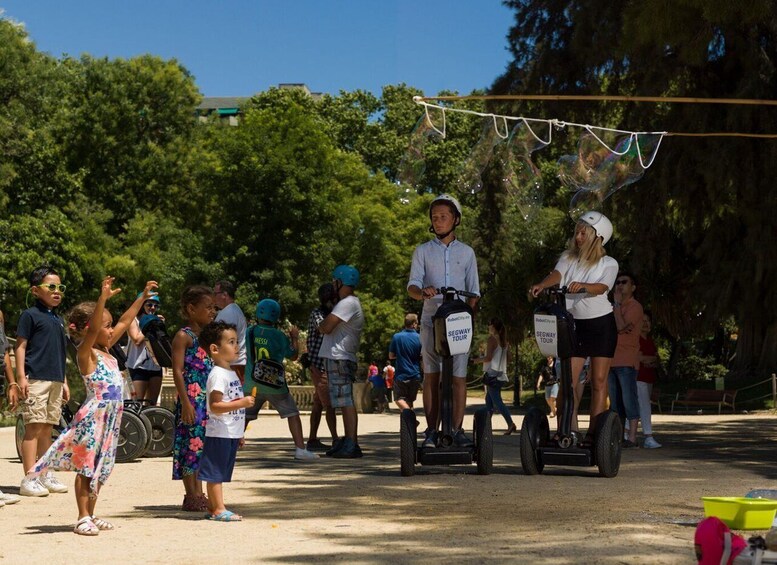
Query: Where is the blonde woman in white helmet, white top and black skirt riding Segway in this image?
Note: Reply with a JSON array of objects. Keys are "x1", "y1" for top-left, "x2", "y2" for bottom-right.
[{"x1": 530, "y1": 212, "x2": 618, "y2": 440}]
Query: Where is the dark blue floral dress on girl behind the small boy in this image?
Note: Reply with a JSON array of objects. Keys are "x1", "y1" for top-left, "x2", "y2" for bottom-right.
[{"x1": 173, "y1": 327, "x2": 213, "y2": 480}]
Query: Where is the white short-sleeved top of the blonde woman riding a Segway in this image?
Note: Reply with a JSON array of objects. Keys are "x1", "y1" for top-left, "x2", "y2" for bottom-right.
[{"x1": 554, "y1": 253, "x2": 618, "y2": 320}]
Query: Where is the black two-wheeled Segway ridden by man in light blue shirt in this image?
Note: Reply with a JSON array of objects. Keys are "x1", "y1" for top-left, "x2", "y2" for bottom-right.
[{"x1": 399, "y1": 287, "x2": 494, "y2": 477}]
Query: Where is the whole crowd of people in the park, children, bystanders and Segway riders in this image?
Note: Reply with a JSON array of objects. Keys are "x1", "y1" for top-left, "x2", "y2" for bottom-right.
[{"x1": 0, "y1": 194, "x2": 660, "y2": 536}]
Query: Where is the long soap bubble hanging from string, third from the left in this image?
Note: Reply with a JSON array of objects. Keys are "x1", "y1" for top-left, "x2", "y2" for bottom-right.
[{"x1": 495, "y1": 120, "x2": 551, "y2": 219}]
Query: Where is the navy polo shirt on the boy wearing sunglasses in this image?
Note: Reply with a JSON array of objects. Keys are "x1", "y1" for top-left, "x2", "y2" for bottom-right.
[{"x1": 16, "y1": 301, "x2": 67, "y2": 383}]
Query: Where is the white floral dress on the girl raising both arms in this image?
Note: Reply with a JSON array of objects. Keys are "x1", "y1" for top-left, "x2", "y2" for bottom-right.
[{"x1": 28, "y1": 349, "x2": 124, "y2": 494}]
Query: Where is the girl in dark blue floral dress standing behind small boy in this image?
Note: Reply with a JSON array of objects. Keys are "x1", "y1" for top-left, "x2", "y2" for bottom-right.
[{"x1": 173, "y1": 285, "x2": 216, "y2": 512}]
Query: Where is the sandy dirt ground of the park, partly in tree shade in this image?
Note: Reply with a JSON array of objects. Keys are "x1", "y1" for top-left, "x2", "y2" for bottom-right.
[{"x1": 0, "y1": 400, "x2": 777, "y2": 564}]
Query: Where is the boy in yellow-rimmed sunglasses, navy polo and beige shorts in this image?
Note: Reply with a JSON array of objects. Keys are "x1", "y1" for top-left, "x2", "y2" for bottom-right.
[{"x1": 8, "y1": 265, "x2": 70, "y2": 496}]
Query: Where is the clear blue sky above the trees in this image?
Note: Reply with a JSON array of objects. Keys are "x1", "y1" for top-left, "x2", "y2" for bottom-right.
[{"x1": 0, "y1": 0, "x2": 513, "y2": 96}]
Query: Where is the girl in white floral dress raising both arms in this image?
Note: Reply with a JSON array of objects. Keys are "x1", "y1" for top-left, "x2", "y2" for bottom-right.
[{"x1": 27, "y1": 277, "x2": 157, "y2": 536}]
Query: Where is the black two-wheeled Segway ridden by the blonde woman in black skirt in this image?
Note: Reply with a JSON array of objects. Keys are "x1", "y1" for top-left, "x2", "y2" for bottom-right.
[{"x1": 520, "y1": 287, "x2": 623, "y2": 477}]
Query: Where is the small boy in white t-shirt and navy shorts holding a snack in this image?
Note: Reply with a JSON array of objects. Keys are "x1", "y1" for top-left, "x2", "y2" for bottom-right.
[{"x1": 199, "y1": 322, "x2": 256, "y2": 522}]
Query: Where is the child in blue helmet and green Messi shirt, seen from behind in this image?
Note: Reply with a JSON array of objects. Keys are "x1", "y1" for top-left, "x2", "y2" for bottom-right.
[{"x1": 243, "y1": 298, "x2": 318, "y2": 461}]
